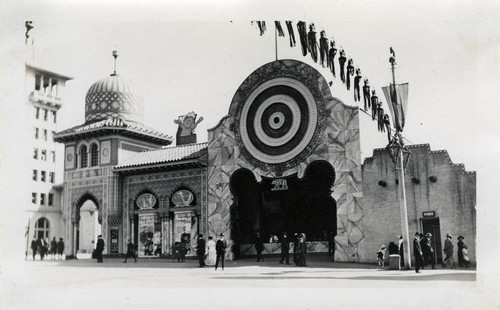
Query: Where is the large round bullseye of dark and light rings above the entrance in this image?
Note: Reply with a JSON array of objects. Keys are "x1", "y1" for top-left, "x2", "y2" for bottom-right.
[{"x1": 238, "y1": 77, "x2": 318, "y2": 164}]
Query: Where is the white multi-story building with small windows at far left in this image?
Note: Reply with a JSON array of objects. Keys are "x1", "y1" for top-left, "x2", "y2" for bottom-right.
[{"x1": 24, "y1": 64, "x2": 72, "y2": 257}]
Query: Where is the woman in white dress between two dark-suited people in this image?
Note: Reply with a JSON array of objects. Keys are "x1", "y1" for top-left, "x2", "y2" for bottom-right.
[{"x1": 196, "y1": 233, "x2": 227, "y2": 270}]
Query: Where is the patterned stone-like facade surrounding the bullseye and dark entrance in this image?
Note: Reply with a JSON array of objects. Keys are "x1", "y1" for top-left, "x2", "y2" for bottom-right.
[{"x1": 207, "y1": 60, "x2": 364, "y2": 261}]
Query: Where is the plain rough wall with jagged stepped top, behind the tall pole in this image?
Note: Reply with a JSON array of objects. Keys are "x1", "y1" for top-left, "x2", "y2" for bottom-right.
[{"x1": 360, "y1": 144, "x2": 476, "y2": 262}]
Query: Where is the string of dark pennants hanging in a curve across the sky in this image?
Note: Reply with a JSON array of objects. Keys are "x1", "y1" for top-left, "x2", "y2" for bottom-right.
[{"x1": 251, "y1": 21, "x2": 393, "y2": 140}]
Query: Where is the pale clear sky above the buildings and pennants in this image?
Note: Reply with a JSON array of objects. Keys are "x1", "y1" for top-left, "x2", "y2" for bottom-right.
[{"x1": 0, "y1": 0, "x2": 500, "y2": 308}]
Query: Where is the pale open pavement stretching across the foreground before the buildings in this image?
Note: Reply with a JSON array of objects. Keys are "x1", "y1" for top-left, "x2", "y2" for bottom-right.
[{"x1": 2, "y1": 257, "x2": 493, "y2": 310}]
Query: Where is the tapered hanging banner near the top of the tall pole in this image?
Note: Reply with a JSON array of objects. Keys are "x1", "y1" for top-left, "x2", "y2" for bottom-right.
[{"x1": 382, "y1": 83, "x2": 408, "y2": 131}]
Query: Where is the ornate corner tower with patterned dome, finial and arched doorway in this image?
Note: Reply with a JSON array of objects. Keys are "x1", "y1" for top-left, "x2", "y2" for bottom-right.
[{"x1": 54, "y1": 51, "x2": 173, "y2": 256}]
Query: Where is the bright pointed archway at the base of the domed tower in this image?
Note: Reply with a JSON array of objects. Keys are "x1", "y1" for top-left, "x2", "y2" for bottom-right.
[{"x1": 75, "y1": 194, "x2": 102, "y2": 258}]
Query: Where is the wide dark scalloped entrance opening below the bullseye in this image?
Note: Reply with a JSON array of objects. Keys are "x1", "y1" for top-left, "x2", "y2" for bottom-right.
[{"x1": 230, "y1": 161, "x2": 337, "y2": 255}]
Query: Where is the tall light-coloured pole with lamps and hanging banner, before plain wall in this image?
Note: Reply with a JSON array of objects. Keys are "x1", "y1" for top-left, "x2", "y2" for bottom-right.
[{"x1": 382, "y1": 47, "x2": 411, "y2": 269}]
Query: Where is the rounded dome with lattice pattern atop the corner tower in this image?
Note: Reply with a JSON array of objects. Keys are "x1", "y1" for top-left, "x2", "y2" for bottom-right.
[{"x1": 85, "y1": 74, "x2": 143, "y2": 123}]
